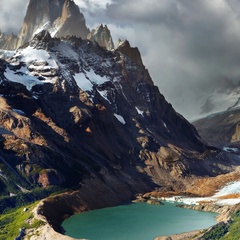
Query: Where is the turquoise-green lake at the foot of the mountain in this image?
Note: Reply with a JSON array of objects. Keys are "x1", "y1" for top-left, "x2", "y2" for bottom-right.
[{"x1": 62, "y1": 203, "x2": 216, "y2": 240}]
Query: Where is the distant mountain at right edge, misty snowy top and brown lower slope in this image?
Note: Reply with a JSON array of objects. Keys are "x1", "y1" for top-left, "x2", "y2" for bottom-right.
[{"x1": 193, "y1": 79, "x2": 240, "y2": 152}]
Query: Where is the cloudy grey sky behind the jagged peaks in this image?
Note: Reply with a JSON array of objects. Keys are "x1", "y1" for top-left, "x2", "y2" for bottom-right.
[{"x1": 0, "y1": 0, "x2": 240, "y2": 118}]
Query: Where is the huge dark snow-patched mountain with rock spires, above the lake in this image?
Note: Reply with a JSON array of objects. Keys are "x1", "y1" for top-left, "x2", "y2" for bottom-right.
[{"x1": 0, "y1": 0, "x2": 237, "y2": 234}]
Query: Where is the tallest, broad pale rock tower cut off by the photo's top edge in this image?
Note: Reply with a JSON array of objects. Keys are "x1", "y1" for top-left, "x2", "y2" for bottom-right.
[{"x1": 16, "y1": 0, "x2": 89, "y2": 48}]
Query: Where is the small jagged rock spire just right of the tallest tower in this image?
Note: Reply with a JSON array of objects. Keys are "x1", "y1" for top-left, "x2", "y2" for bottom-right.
[{"x1": 87, "y1": 24, "x2": 114, "y2": 50}]
